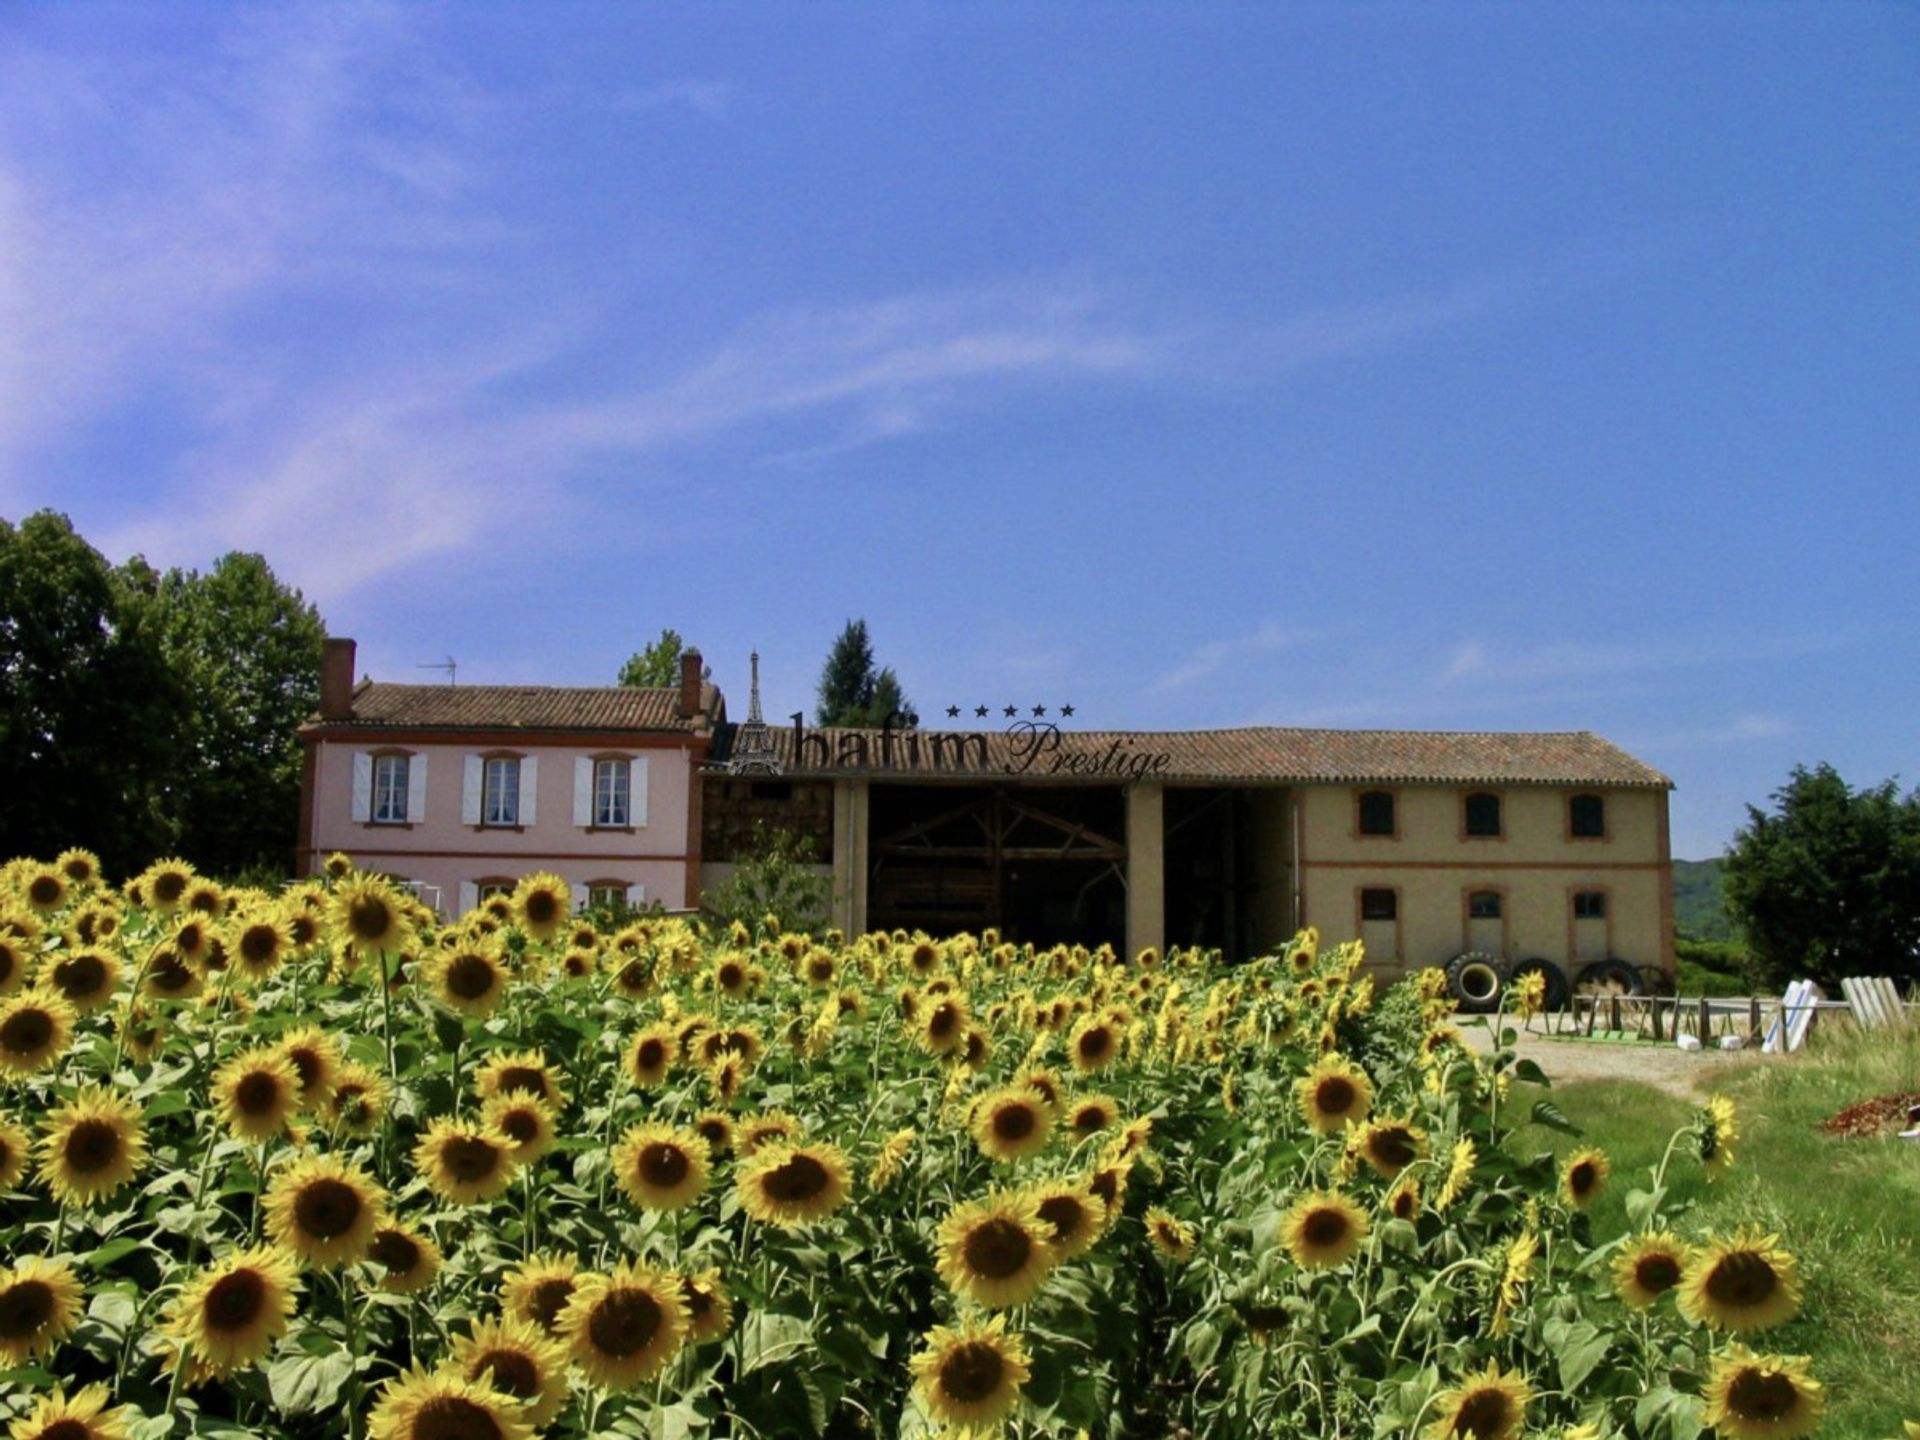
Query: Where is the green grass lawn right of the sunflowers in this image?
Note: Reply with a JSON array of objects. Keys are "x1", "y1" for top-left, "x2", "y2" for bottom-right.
[{"x1": 1515, "y1": 1027, "x2": 1920, "y2": 1440}]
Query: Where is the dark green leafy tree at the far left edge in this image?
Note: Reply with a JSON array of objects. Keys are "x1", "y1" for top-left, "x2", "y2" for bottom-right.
[{"x1": 0, "y1": 511, "x2": 188, "y2": 874}]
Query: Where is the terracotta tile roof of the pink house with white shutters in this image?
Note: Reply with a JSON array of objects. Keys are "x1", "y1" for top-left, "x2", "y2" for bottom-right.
[{"x1": 307, "y1": 680, "x2": 714, "y2": 732}]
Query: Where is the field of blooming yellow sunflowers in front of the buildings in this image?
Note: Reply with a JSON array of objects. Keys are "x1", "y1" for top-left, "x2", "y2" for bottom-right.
[{"x1": 0, "y1": 851, "x2": 1824, "y2": 1440}]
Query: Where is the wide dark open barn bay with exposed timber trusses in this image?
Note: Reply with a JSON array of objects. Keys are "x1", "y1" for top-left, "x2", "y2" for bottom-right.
[{"x1": 868, "y1": 785, "x2": 1127, "y2": 950}]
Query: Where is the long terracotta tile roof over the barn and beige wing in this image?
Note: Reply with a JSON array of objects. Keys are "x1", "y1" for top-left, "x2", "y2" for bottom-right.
[{"x1": 714, "y1": 726, "x2": 1672, "y2": 789}]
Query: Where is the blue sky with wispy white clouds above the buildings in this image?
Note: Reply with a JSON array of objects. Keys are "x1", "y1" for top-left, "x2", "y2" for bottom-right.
[{"x1": 0, "y1": 0, "x2": 1920, "y2": 854}]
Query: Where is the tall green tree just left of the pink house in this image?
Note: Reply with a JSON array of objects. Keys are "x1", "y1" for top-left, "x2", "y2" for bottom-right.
[{"x1": 157, "y1": 551, "x2": 326, "y2": 876}]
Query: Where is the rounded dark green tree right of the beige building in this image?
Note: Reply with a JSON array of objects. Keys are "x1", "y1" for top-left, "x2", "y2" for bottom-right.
[{"x1": 1726, "y1": 764, "x2": 1920, "y2": 985}]
